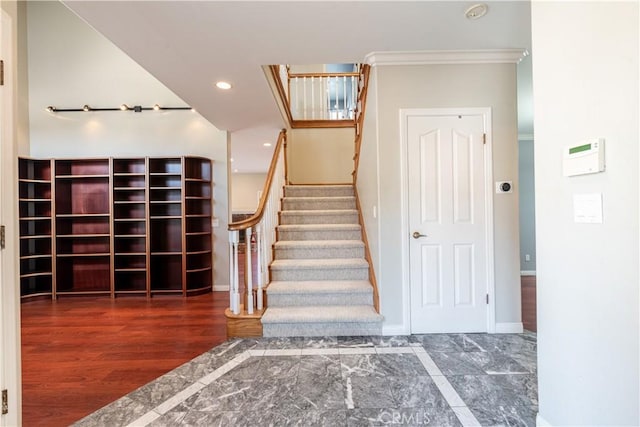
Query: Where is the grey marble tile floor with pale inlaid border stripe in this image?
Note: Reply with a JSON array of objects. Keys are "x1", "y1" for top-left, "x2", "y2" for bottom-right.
[{"x1": 74, "y1": 332, "x2": 538, "y2": 427}]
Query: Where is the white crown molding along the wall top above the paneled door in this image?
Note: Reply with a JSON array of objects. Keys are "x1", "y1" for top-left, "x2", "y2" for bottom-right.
[{"x1": 364, "y1": 49, "x2": 529, "y2": 67}]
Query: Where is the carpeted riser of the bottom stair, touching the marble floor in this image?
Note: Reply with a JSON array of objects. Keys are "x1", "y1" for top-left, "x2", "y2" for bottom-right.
[{"x1": 262, "y1": 322, "x2": 382, "y2": 337}]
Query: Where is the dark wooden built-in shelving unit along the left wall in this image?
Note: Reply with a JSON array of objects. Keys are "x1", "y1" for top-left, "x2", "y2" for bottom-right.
[{"x1": 19, "y1": 157, "x2": 213, "y2": 298}]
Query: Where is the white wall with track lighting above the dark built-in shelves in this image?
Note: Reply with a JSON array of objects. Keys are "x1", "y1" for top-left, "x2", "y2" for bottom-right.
[{"x1": 27, "y1": 2, "x2": 229, "y2": 287}]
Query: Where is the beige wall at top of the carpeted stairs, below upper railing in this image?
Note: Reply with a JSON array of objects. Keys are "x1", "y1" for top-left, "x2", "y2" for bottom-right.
[{"x1": 287, "y1": 128, "x2": 355, "y2": 184}]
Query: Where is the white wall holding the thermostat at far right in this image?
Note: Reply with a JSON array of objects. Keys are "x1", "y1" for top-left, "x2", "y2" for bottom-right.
[{"x1": 531, "y1": 1, "x2": 640, "y2": 426}]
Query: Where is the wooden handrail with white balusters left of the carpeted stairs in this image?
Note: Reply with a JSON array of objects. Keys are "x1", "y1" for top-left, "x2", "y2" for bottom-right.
[{"x1": 228, "y1": 130, "x2": 287, "y2": 315}]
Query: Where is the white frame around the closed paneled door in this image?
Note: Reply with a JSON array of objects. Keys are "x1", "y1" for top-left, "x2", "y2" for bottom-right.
[{"x1": 399, "y1": 107, "x2": 496, "y2": 334}]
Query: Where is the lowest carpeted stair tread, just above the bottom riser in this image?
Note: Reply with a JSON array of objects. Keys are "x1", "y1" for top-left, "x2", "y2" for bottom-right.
[{"x1": 262, "y1": 305, "x2": 383, "y2": 324}]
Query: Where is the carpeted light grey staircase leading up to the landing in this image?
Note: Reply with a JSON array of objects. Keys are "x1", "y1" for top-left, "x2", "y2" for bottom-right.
[{"x1": 262, "y1": 185, "x2": 383, "y2": 337}]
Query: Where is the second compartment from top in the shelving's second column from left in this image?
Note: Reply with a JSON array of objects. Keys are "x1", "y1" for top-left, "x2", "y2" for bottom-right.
[{"x1": 55, "y1": 179, "x2": 110, "y2": 215}]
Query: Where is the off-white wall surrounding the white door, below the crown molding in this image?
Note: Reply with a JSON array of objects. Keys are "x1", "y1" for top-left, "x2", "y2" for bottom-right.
[{"x1": 358, "y1": 64, "x2": 521, "y2": 332}]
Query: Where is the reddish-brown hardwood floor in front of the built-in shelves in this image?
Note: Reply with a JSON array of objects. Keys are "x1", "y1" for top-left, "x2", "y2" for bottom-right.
[{"x1": 22, "y1": 292, "x2": 229, "y2": 427}]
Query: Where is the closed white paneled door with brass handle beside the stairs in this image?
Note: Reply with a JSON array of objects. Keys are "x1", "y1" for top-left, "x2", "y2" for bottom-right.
[{"x1": 404, "y1": 114, "x2": 490, "y2": 333}]
